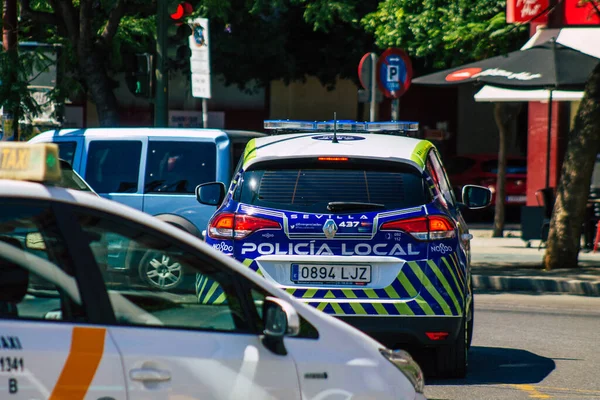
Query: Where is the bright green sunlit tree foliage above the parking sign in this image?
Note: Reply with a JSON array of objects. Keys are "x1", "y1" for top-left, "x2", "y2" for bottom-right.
[{"x1": 362, "y1": 0, "x2": 527, "y2": 70}]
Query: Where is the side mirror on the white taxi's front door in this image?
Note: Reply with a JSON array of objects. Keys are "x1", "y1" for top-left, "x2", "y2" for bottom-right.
[{"x1": 262, "y1": 296, "x2": 300, "y2": 356}]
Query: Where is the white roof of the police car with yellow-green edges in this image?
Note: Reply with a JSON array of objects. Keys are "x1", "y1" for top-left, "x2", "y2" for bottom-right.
[{"x1": 244, "y1": 132, "x2": 433, "y2": 170}]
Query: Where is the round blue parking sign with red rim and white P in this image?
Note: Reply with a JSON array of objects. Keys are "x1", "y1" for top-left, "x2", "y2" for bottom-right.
[{"x1": 377, "y1": 48, "x2": 412, "y2": 99}]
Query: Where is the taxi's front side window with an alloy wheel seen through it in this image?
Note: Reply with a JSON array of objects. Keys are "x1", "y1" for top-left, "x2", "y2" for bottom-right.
[{"x1": 76, "y1": 210, "x2": 250, "y2": 332}]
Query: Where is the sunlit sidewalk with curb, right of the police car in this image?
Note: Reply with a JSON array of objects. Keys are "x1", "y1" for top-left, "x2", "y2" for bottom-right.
[{"x1": 470, "y1": 226, "x2": 600, "y2": 296}]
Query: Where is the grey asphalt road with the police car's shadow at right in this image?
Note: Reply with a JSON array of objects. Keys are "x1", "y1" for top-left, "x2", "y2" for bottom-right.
[{"x1": 425, "y1": 294, "x2": 600, "y2": 400}]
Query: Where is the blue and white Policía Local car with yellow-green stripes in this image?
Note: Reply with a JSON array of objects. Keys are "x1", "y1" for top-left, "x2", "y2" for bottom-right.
[{"x1": 197, "y1": 121, "x2": 491, "y2": 377}]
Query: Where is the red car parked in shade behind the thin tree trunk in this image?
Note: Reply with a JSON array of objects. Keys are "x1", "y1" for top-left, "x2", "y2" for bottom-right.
[{"x1": 444, "y1": 154, "x2": 527, "y2": 206}]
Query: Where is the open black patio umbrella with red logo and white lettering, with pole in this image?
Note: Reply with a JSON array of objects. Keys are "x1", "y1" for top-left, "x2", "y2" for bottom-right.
[{"x1": 413, "y1": 38, "x2": 600, "y2": 187}]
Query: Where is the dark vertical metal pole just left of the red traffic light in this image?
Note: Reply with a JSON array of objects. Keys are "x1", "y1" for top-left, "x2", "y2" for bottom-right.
[{"x1": 154, "y1": 0, "x2": 169, "y2": 127}]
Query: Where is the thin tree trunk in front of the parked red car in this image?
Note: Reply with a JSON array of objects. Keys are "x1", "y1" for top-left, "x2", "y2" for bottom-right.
[{"x1": 492, "y1": 103, "x2": 521, "y2": 237}]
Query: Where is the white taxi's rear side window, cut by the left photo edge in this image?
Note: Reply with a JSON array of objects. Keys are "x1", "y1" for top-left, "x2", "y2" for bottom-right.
[{"x1": 0, "y1": 200, "x2": 86, "y2": 322}]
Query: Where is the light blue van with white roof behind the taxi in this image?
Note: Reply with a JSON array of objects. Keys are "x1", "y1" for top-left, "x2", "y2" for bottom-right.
[{"x1": 29, "y1": 128, "x2": 264, "y2": 290}]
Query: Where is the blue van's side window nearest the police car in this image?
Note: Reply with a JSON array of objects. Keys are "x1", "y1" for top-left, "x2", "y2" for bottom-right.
[{"x1": 144, "y1": 141, "x2": 217, "y2": 194}]
